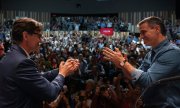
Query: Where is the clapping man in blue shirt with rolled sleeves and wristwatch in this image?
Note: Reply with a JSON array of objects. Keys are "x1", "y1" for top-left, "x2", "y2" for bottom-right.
[{"x1": 103, "y1": 16, "x2": 180, "y2": 108}]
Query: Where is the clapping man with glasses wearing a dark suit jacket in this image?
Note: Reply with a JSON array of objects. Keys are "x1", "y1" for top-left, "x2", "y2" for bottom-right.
[{"x1": 0, "y1": 18, "x2": 79, "y2": 108}]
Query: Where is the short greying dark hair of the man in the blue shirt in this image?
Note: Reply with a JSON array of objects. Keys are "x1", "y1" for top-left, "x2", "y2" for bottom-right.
[{"x1": 137, "y1": 16, "x2": 166, "y2": 36}]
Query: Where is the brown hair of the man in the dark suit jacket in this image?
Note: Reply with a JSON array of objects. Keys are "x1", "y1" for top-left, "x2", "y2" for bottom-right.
[{"x1": 12, "y1": 17, "x2": 43, "y2": 43}]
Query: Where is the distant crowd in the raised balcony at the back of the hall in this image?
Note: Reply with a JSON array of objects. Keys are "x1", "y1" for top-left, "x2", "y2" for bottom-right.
[{"x1": 50, "y1": 16, "x2": 129, "y2": 32}]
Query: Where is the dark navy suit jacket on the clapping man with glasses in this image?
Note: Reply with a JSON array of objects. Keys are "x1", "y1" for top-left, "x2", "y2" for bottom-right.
[{"x1": 0, "y1": 45, "x2": 64, "y2": 108}]
